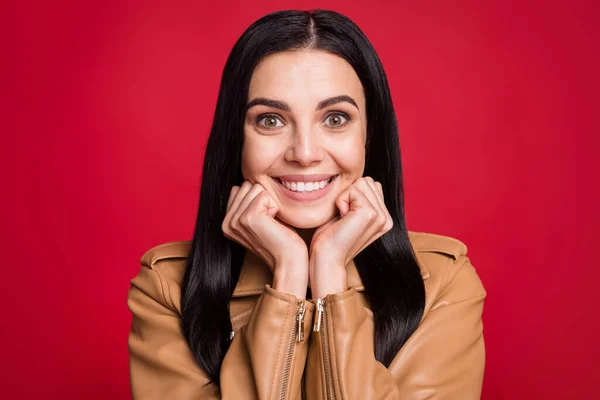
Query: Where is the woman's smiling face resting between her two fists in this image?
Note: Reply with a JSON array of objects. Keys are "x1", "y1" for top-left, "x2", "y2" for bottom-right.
[{"x1": 242, "y1": 50, "x2": 367, "y2": 228}]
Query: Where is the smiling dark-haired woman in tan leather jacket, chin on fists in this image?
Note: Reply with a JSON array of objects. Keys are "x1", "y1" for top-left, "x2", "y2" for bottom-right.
[{"x1": 128, "y1": 10, "x2": 485, "y2": 399}]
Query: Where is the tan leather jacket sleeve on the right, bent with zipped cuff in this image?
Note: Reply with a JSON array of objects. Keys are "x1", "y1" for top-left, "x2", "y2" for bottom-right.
[{"x1": 306, "y1": 256, "x2": 486, "y2": 400}]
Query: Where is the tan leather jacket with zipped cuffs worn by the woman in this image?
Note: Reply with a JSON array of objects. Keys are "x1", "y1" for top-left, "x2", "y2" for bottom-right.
[{"x1": 127, "y1": 232, "x2": 486, "y2": 400}]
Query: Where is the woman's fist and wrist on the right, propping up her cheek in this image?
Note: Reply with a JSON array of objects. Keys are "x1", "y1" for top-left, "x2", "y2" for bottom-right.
[{"x1": 309, "y1": 177, "x2": 394, "y2": 298}]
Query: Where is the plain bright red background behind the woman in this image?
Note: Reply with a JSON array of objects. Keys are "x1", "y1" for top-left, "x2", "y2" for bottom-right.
[{"x1": 5, "y1": 0, "x2": 600, "y2": 400}]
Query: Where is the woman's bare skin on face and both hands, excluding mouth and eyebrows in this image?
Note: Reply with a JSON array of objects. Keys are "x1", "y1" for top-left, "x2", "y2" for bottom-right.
[{"x1": 223, "y1": 50, "x2": 393, "y2": 299}]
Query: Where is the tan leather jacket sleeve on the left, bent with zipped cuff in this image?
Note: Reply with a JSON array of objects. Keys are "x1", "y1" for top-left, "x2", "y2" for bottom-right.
[{"x1": 127, "y1": 265, "x2": 314, "y2": 400}]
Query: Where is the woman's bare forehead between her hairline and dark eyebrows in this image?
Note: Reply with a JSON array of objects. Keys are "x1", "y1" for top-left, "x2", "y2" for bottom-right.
[{"x1": 248, "y1": 50, "x2": 364, "y2": 110}]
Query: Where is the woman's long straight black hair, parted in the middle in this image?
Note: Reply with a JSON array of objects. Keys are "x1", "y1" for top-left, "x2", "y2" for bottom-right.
[{"x1": 182, "y1": 9, "x2": 425, "y2": 384}]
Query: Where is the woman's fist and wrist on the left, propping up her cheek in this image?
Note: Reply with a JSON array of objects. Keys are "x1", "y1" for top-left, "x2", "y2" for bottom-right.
[{"x1": 221, "y1": 181, "x2": 308, "y2": 299}]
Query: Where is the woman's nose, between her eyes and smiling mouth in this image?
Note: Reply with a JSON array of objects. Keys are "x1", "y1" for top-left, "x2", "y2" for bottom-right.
[{"x1": 285, "y1": 124, "x2": 324, "y2": 167}]
